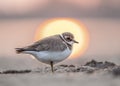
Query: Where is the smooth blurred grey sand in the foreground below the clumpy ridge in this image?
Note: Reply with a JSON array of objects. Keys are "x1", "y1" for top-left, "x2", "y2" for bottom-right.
[{"x1": 0, "y1": 73, "x2": 120, "y2": 86}]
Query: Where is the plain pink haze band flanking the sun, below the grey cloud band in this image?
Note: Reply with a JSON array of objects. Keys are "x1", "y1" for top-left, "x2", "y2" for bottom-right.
[{"x1": 0, "y1": 18, "x2": 120, "y2": 56}]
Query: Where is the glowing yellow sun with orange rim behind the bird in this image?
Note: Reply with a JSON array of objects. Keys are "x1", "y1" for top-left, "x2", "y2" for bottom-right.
[{"x1": 35, "y1": 18, "x2": 88, "y2": 58}]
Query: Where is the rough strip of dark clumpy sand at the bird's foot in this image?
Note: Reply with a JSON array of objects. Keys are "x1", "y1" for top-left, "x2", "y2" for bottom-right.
[{"x1": 0, "y1": 60, "x2": 120, "y2": 76}]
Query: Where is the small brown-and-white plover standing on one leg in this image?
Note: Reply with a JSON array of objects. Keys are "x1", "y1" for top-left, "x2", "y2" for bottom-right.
[{"x1": 16, "y1": 32, "x2": 78, "y2": 72}]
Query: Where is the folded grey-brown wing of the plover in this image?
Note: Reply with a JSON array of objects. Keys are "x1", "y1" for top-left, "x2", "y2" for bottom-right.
[{"x1": 24, "y1": 36, "x2": 66, "y2": 51}]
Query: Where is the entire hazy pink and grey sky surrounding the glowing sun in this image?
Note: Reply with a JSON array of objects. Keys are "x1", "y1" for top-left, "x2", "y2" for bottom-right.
[{"x1": 0, "y1": 0, "x2": 120, "y2": 59}]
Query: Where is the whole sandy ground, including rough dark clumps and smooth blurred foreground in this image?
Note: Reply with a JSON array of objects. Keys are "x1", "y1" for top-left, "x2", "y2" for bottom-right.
[{"x1": 0, "y1": 57, "x2": 120, "y2": 86}]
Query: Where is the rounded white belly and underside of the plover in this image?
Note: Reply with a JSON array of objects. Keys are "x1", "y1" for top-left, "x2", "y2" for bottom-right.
[{"x1": 24, "y1": 49, "x2": 71, "y2": 64}]
